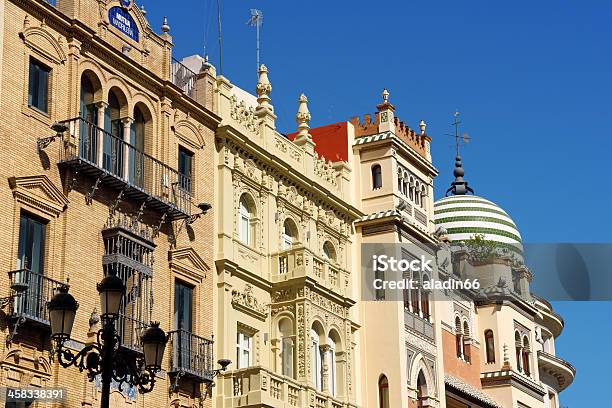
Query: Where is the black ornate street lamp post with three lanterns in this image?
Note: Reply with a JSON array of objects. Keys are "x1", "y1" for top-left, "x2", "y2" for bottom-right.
[{"x1": 47, "y1": 272, "x2": 168, "y2": 408}]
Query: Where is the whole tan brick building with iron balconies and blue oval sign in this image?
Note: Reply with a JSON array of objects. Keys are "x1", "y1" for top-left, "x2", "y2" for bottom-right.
[{"x1": 0, "y1": 0, "x2": 220, "y2": 407}]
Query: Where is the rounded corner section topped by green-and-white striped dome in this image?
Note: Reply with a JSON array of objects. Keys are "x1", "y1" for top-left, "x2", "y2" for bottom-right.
[{"x1": 434, "y1": 160, "x2": 576, "y2": 408}]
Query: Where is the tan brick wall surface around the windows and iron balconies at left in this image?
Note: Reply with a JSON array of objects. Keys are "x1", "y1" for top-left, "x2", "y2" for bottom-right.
[{"x1": 0, "y1": 0, "x2": 219, "y2": 407}]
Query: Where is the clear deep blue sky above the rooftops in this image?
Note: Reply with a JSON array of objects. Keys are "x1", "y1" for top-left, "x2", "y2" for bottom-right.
[{"x1": 140, "y1": 0, "x2": 612, "y2": 408}]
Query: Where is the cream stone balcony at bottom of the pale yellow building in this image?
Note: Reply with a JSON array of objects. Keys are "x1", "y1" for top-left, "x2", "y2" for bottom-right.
[{"x1": 220, "y1": 367, "x2": 354, "y2": 408}]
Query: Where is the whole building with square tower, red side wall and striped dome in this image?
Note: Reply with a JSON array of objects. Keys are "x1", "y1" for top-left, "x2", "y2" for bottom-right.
[{"x1": 310, "y1": 95, "x2": 575, "y2": 408}]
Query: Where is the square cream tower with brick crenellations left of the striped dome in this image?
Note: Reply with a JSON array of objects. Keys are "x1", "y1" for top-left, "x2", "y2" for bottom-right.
[{"x1": 351, "y1": 90, "x2": 444, "y2": 407}]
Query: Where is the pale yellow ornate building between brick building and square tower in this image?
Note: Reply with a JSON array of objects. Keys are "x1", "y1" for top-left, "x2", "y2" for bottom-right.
[{"x1": 209, "y1": 65, "x2": 361, "y2": 408}]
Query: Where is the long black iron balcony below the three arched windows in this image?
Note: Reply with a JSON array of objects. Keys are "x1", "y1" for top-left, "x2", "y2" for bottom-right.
[{"x1": 59, "y1": 118, "x2": 191, "y2": 220}]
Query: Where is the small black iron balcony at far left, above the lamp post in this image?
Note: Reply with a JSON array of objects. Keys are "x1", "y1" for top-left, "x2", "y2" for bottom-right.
[{"x1": 7, "y1": 269, "x2": 64, "y2": 326}]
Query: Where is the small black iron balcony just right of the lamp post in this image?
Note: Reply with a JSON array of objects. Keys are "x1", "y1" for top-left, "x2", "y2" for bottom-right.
[{"x1": 168, "y1": 330, "x2": 214, "y2": 383}]
